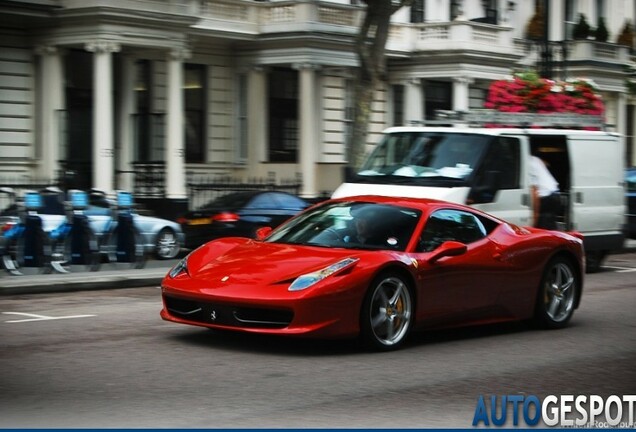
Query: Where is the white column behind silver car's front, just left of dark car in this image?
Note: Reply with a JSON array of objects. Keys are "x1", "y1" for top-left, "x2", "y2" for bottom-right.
[{"x1": 165, "y1": 50, "x2": 190, "y2": 199}]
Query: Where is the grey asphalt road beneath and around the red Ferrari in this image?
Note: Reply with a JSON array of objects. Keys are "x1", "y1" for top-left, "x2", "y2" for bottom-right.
[{"x1": 0, "y1": 253, "x2": 636, "y2": 428}]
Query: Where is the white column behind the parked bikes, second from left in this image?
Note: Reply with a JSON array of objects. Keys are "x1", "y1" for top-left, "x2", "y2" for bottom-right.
[{"x1": 86, "y1": 41, "x2": 120, "y2": 194}]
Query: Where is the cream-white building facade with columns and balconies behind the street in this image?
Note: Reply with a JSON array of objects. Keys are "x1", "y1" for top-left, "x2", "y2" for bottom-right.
[{"x1": 0, "y1": 0, "x2": 636, "y2": 214}]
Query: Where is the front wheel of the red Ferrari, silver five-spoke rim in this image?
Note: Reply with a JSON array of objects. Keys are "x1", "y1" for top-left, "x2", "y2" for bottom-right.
[{"x1": 360, "y1": 272, "x2": 414, "y2": 351}]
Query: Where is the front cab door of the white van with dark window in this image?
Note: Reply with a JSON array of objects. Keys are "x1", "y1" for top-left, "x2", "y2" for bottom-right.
[{"x1": 467, "y1": 136, "x2": 532, "y2": 226}]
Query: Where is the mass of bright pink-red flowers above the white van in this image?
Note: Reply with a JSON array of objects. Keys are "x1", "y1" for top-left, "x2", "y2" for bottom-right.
[{"x1": 484, "y1": 72, "x2": 605, "y2": 127}]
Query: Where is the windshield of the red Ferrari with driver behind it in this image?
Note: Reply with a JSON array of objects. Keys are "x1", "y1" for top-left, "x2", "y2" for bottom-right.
[{"x1": 265, "y1": 202, "x2": 421, "y2": 251}]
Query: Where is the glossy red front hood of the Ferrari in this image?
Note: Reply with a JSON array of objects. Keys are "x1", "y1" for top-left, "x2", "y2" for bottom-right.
[{"x1": 188, "y1": 238, "x2": 362, "y2": 286}]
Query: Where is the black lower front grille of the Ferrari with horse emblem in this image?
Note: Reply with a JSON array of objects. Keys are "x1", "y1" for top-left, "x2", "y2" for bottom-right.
[{"x1": 164, "y1": 296, "x2": 294, "y2": 329}]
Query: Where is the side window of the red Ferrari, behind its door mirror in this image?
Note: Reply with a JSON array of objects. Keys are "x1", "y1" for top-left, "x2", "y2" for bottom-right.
[{"x1": 417, "y1": 210, "x2": 487, "y2": 252}]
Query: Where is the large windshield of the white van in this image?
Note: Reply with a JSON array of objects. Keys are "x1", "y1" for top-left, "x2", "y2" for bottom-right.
[{"x1": 355, "y1": 132, "x2": 492, "y2": 184}]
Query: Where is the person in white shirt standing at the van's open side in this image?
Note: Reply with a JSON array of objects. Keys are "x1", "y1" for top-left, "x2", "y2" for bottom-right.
[{"x1": 529, "y1": 156, "x2": 561, "y2": 230}]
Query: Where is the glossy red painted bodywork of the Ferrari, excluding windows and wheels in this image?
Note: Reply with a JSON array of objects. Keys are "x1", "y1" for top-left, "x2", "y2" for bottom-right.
[{"x1": 161, "y1": 196, "x2": 584, "y2": 338}]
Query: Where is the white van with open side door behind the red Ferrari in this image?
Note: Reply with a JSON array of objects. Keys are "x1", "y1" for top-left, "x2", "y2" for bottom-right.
[{"x1": 332, "y1": 115, "x2": 626, "y2": 271}]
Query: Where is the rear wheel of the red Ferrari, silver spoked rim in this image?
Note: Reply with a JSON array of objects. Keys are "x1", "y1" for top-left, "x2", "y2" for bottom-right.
[{"x1": 534, "y1": 257, "x2": 581, "y2": 329}]
